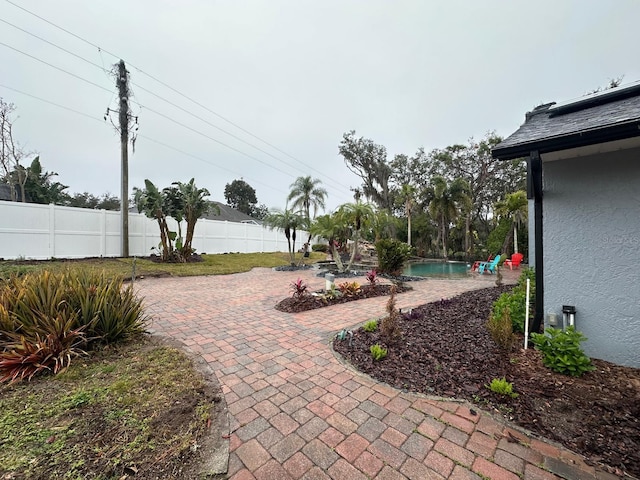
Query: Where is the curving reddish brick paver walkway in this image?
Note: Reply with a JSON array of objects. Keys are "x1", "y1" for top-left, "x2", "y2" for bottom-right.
[{"x1": 136, "y1": 268, "x2": 616, "y2": 480}]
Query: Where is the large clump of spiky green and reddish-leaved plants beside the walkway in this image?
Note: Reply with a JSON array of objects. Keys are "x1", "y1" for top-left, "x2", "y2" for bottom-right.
[{"x1": 0, "y1": 271, "x2": 146, "y2": 382}]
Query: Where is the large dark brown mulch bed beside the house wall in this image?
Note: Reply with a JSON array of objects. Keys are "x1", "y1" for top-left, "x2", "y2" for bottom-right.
[{"x1": 334, "y1": 287, "x2": 640, "y2": 477}]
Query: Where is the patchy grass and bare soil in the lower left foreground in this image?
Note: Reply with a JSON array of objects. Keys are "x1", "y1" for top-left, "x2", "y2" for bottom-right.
[{"x1": 0, "y1": 337, "x2": 216, "y2": 480}]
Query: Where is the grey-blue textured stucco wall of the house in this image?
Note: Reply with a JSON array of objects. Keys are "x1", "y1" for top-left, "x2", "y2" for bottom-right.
[{"x1": 543, "y1": 148, "x2": 640, "y2": 367}]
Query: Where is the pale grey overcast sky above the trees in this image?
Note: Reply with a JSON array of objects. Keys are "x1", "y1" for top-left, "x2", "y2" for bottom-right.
[{"x1": 0, "y1": 0, "x2": 640, "y2": 209}]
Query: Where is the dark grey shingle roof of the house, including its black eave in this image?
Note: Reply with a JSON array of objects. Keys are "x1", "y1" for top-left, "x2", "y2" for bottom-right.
[{"x1": 493, "y1": 84, "x2": 640, "y2": 159}]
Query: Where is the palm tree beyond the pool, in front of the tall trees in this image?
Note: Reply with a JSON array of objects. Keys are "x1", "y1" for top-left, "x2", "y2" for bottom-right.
[{"x1": 429, "y1": 176, "x2": 469, "y2": 258}]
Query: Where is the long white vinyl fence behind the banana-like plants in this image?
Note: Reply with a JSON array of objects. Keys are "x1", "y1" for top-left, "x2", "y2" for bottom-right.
[{"x1": 0, "y1": 201, "x2": 307, "y2": 260}]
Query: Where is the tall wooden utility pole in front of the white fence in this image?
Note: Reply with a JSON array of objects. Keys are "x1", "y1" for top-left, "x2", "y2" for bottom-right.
[{"x1": 116, "y1": 60, "x2": 129, "y2": 258}]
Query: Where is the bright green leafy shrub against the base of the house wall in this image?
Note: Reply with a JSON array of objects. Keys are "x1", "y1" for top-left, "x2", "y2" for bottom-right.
[{"x1": 531, "y1": 327, "x2": 595, "y2": 377}]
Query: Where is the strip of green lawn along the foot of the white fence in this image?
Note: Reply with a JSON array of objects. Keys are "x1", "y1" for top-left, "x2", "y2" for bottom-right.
[{"x1": 0, "y1": 252, "x2": 325, "y2": 280}]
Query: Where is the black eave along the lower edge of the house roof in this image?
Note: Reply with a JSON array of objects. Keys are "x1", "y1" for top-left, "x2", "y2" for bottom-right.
[{"x1": 491, "y1": 119, "x2": 640, "y2": 160}]
